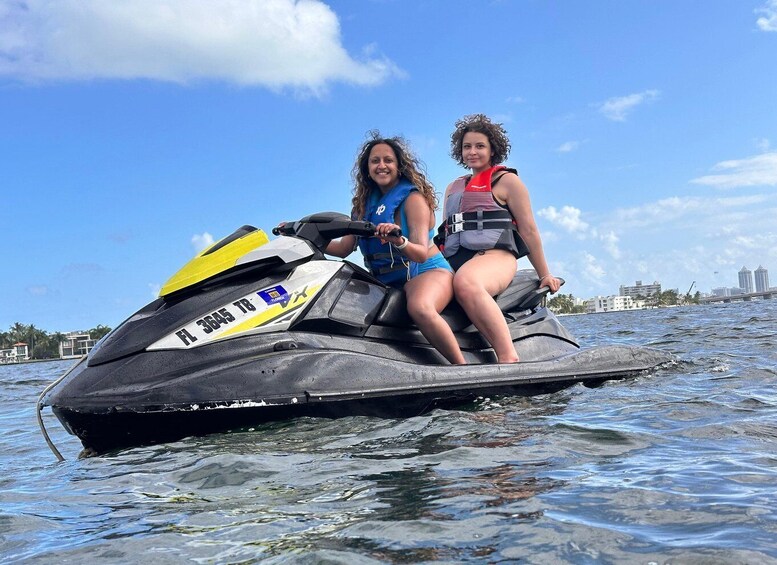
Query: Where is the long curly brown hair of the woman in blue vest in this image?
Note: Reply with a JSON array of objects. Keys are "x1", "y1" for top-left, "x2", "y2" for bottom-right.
[{"x1": 351, "y1": 130, "x2": 437, "y2": 218}]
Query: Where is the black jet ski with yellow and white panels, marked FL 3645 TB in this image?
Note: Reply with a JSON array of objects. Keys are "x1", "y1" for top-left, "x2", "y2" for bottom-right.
[{"x1": 38, "y1": 212, "x2": 670, "y2": 454}]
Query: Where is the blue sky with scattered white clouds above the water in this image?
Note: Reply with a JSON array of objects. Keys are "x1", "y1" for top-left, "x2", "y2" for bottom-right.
[{"x1": 0, "y1": 0, "x2": 777, "y2": 332}]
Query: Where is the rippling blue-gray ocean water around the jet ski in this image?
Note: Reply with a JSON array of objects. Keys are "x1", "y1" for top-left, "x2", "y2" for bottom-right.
[{"x1": 0, "y1": 301, "x2": 777, "y2": 564}]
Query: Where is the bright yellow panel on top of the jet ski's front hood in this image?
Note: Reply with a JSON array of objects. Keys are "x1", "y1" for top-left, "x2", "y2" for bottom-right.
[{"x1": 159, "y1": 226, "x2": 270, "y2": 297}]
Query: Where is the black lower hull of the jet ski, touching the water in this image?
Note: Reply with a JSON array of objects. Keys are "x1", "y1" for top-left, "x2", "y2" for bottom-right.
[{"x1": 49, "y1": 346, "x2": 669, "y2": 453}]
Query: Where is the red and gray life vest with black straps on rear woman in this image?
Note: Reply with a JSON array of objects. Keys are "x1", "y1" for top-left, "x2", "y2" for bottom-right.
[{"x1": 435, "y1": 165, "x2": 529, "y2": 258}]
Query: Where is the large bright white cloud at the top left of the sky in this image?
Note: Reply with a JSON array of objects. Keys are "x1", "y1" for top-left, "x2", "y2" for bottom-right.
[{"x1": 0, "y1": 0, "x2": 402, "y2": 93}]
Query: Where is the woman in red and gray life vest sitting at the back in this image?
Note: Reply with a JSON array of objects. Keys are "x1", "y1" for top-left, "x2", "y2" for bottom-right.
[{"x1": 441, "y1": 114, "x2": 561, "y2": 363}]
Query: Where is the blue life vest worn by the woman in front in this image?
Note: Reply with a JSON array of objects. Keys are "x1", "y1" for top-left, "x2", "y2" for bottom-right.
[{"x1": 359, "y1": 178, "x2": 418, "y2": 286}]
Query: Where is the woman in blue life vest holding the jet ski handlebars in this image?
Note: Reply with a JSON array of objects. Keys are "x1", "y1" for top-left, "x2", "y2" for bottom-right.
[{"x1": 326, "y1": 131, "x2": 465, "y2": 364}]
